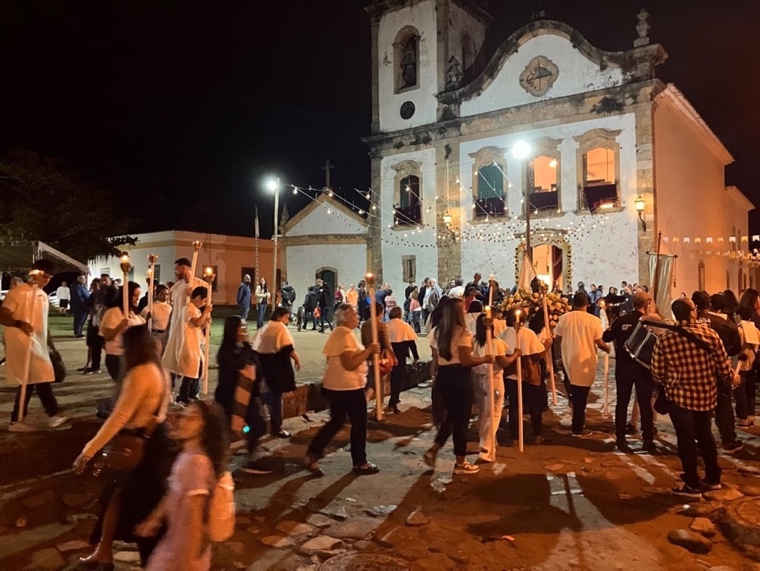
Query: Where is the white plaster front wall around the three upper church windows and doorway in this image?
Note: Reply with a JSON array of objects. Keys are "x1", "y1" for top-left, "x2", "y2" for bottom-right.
[{"x1": 454, "y1": 113, "x2": 638, "y2": 287}]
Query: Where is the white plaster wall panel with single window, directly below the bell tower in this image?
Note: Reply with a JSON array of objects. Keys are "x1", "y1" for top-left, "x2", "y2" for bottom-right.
[{"x1": 378, "y1": 149, "x2": 440, "y2": 290}]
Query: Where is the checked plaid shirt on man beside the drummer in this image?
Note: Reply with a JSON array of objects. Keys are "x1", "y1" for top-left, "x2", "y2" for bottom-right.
[{"x1": 652, "y1": 322, "x2": 733, "y2": 411}]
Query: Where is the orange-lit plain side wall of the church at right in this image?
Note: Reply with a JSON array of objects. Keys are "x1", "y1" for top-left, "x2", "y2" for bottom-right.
[{"x1": 654, "y1": 97, "x2": 748, "y2": 296}]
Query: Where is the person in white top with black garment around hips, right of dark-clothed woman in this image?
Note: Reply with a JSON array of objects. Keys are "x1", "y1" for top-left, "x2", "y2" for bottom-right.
[{"x1": 253, "y1": 307, "x2": 301, "y2": 438}]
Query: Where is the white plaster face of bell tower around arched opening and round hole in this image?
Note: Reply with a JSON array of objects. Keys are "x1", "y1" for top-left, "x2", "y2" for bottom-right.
[{"x1": 378, "y1": 0, "x2": 438, "y2": 132}]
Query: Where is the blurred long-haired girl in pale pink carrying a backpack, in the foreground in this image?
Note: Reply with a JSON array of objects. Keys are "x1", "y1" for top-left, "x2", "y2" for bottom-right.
[{"x1": 136, "y1": 400, "x2": 229, "y2": 571}]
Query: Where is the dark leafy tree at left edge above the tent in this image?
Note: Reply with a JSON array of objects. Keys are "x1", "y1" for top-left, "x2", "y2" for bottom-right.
[{"x1": 0, "y1": 149, "x2": 134, "y2": 262}]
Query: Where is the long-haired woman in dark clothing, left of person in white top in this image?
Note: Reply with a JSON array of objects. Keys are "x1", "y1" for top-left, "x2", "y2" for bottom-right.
[{"x1": 214, "y1": 315, "x2": 271, "y2": 474}]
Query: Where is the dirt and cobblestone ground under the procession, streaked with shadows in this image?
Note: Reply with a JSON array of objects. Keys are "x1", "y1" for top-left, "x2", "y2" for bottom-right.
[{"x1": 0, "y1": 316, "x2": 760, "y2": 571}]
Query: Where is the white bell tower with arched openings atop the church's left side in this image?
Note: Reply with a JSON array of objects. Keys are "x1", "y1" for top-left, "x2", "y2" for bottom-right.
[{"x1": 366, "y1": 0, "x2": 492, "y2": 133}]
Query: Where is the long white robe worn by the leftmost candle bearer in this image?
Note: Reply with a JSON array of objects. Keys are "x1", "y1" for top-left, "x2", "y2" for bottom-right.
[{"x1": 3, "y1": 284, "x2": 55, "y2": 387}]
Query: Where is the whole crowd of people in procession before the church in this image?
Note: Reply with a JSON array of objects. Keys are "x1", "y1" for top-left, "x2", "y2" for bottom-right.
[{"x1": 0, "y1": 258, "x2": 760, "y2": 569}]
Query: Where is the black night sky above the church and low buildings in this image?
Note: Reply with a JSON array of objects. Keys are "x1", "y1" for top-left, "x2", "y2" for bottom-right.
[{"x1": 0, "y1": 0, "x2": 760, "y2": 235}]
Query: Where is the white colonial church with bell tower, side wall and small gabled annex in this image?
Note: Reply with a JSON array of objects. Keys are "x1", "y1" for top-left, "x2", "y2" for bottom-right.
[{"x1": 283, "y1": 0, "x2": 758, "y2": 297}]
